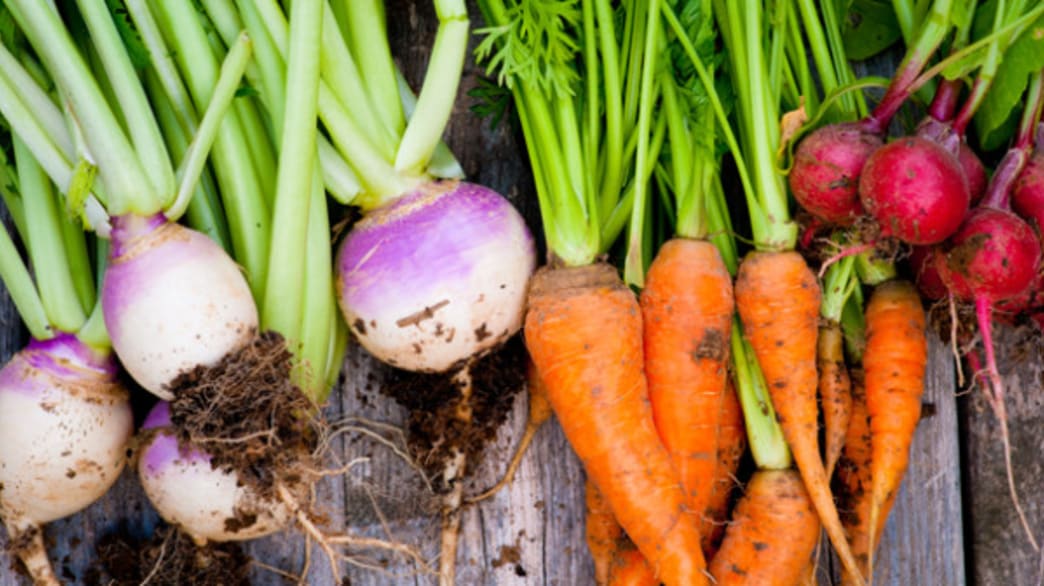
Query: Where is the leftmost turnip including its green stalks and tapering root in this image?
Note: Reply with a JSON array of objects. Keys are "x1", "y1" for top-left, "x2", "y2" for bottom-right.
[{"x1": 0, "y1": 138, "x2": 134, "y2": 584}]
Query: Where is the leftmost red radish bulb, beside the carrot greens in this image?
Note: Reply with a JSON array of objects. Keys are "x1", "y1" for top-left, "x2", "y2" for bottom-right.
[{"x1": 788, "y1": 124, "x2": 884, "y2": 226}]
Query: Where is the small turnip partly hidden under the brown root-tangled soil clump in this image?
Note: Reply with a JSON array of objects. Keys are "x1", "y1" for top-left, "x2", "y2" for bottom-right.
[{"x1": 138, "y1": 401, "x2": 292, "y2": 545}]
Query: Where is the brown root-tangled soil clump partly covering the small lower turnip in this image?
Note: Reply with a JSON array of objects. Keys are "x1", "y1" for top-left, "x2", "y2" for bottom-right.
[{"x1": 169, "y1": 332, "x2": 318, "y2": 496}]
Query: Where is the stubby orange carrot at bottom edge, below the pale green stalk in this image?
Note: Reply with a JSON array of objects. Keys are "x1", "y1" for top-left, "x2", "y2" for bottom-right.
[{"x1": 710, "y1": 470, "x2": 820, "y2": 586}]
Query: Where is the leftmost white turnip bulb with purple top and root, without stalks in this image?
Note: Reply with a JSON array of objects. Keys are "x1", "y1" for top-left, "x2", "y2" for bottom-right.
[{"x1": 0, "y1": 333, "x2": 134, "y2": 584}]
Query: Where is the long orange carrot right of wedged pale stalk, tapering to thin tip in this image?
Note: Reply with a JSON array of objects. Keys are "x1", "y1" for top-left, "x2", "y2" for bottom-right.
[{"x1": 736, "y1": 252, "x2": 858, "y2": 573}]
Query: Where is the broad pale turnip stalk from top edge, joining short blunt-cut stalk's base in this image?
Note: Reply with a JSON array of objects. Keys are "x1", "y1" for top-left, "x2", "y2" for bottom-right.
[{"x1": 76, "y1": 0, "x2": 174, "y2": 203}]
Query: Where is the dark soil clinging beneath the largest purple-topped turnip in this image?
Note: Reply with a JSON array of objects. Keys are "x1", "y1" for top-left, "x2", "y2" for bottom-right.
[{"x1": 381, "y1": 335, "x2": 526, "y2": 484}]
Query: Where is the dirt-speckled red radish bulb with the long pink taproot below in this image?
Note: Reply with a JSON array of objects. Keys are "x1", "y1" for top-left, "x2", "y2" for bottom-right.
[{"x1": 938, "y1": 207, "x2": 1041, "y2": 302}]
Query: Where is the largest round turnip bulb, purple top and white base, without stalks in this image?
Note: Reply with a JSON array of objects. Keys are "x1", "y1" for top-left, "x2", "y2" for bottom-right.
[{"x1": 336, "y1": 181, "x2": 536, "y2": 372}]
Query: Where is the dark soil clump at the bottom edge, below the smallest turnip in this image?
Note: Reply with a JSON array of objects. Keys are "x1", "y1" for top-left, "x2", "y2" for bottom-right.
[{"x1": 85, "y1": 525, "x2": 251, "y2": 586}]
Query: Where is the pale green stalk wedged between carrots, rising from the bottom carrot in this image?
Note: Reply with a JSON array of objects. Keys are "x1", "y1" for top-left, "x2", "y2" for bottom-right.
[{"x1": 732, "y1": 318, "x2": 792, "y2": 470}]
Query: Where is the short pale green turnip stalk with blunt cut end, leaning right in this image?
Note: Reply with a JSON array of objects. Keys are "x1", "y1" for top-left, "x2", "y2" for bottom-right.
[{"x1": 170, "y1": 32, "x2": 251, "y2": 220}]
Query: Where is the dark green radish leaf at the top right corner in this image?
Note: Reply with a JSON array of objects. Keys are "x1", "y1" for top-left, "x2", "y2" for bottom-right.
[{"x1": 975, "y1": 11, "x2": 1044, "y2": 150}]
